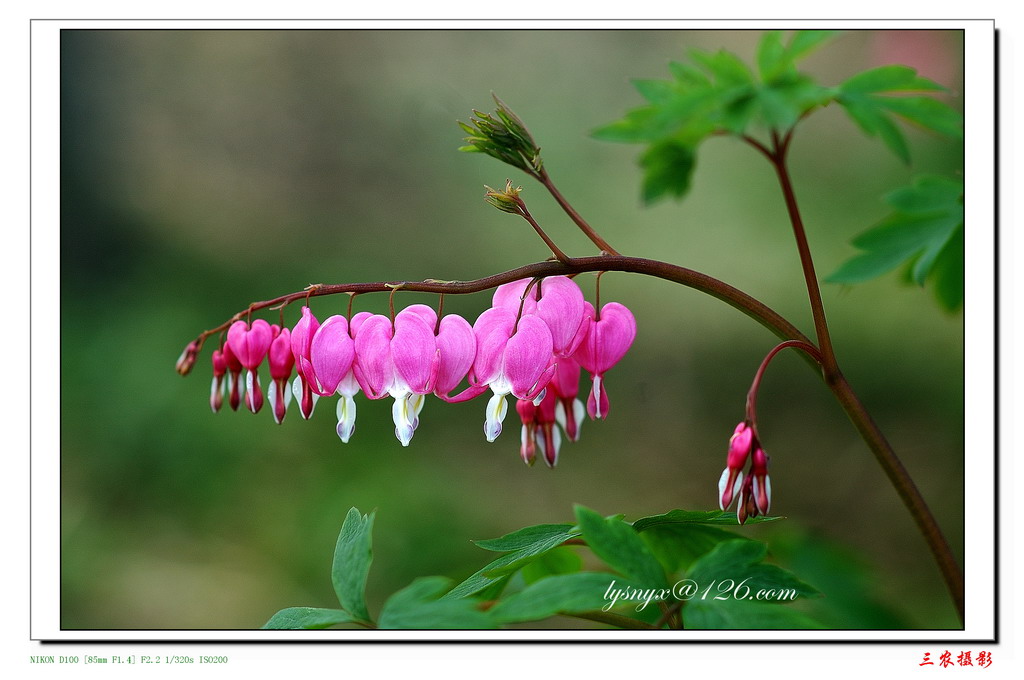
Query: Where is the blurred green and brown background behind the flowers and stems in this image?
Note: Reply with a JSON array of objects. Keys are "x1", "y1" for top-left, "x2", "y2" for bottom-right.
[{"x1": 60, "y1": 31, "x2": 965, "y2": 629}]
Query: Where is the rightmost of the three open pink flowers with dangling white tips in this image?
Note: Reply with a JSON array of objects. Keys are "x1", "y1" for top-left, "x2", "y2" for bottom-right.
[{"x1": 469, "y1": 307, "x2": 555, "y2": 441}]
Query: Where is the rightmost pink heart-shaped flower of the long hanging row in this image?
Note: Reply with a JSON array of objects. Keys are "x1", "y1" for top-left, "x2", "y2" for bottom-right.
[{"x1": 572, "y1": 302, "x2": 637, "y2": 420}]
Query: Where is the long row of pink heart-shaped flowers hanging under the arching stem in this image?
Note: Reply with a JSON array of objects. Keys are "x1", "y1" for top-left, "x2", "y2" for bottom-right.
[{"x1": 210, "y1": 277, "x2": 636, "y2": 466}]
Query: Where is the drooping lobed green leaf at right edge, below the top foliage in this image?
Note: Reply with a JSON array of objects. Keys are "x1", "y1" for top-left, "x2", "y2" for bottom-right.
[{"x1": 826, "y1": 175, "x2": 964, "y2": 309}]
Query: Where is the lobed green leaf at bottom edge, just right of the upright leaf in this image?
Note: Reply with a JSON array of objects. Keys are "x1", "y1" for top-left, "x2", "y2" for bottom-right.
[{"x1": 378, "y1": 577, "x2": 496, "y2": 630}]
